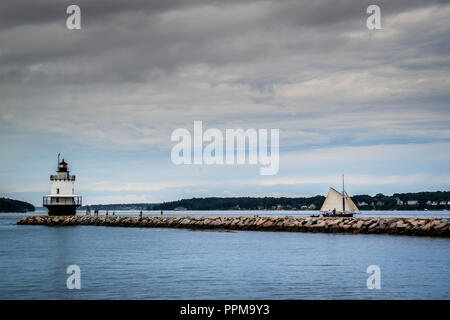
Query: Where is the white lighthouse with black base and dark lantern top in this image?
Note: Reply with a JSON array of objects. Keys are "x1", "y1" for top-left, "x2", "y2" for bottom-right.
[{"x1": 42, "y1": 154, "x2": 81, "y2": 216}]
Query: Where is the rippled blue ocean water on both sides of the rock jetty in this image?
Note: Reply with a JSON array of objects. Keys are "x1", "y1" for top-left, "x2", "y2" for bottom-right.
[{"x1": 0, "y1": 211, "x2": 450, "y2": 299}]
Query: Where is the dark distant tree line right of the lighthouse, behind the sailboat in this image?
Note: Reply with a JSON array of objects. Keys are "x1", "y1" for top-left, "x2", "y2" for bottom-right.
[{"x1": 80, "y1": 191, "x2": 450, "y2": 210}]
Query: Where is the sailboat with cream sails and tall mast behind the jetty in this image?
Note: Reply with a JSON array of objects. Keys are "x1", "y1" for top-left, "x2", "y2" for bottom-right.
[{"x1": 320, "y1": 175, "x2": 359, "y2": 217}]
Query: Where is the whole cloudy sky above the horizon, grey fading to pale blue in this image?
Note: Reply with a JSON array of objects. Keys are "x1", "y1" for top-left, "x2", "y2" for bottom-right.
[{"x1": 0, "y1": 0, "x2": 450, "y2": 206}]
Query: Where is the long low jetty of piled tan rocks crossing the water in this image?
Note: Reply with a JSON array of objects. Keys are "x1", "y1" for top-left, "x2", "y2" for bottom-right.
[{"x1": 17, "y1": 215, "x2": 450, "y2": 237}]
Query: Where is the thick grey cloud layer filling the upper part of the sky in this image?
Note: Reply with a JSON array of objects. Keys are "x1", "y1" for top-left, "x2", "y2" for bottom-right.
[{"x1": 0, "y1": 0, "x2": 450, "y2": 151}]
